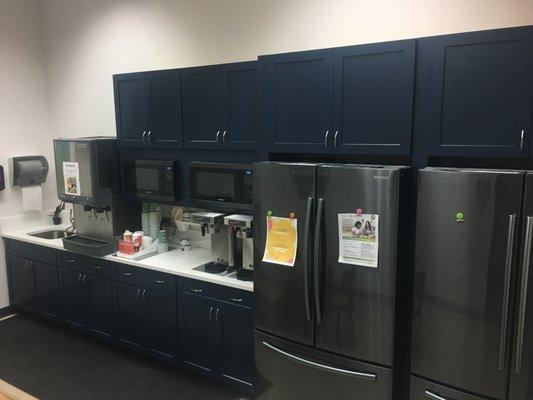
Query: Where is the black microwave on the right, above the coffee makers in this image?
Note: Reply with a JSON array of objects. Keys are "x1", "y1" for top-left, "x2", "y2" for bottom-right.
[{"x1": 189, "y1": 161, "x2": 253, "y2": 209}]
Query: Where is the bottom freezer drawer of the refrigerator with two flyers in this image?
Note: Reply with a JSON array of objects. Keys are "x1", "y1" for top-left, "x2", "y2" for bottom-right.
[{"x1": 255, "y1": 331, "x2": 393, "y2": 400}]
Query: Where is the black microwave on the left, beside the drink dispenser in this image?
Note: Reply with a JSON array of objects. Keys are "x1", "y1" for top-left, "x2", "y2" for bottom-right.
[{"x1": 122, "y1": 160, "x2": 179, "y2": 203}]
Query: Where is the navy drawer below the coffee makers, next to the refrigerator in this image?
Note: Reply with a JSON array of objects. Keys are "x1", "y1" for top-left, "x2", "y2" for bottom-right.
[{"x1": 181, "y1": 278, "x2": 252, "y2": 308}]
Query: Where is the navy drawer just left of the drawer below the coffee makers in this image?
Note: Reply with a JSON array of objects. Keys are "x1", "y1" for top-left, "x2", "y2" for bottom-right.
[{"x1": 112, "y1": 264, "x2": 176, "y2": 291}]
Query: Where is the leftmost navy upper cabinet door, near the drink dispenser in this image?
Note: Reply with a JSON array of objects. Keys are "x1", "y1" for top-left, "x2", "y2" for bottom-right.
[{"x1": 113, "y1": 73, "x2": 148, "y2": 147}]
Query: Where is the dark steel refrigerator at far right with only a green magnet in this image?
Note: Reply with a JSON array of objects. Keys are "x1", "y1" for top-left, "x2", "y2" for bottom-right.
[{"x1": 411, "y1": 168, "x2": 533, "y2": 400}]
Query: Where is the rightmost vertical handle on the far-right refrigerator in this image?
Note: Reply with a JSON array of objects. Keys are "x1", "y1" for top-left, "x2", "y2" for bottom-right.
[{"x1": 515, "y1": 216, "x2": 533, "y2": 374}]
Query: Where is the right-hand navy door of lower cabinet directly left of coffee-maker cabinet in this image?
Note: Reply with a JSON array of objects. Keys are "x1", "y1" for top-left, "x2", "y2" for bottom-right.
[{"x1": 142, "y1": 290, "x2": 178, "y2": 359}]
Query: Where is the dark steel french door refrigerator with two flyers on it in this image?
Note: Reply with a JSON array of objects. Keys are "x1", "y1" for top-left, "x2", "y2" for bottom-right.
[{"x1": 254, "y1": 162, "x2": 410, "y2": 400}]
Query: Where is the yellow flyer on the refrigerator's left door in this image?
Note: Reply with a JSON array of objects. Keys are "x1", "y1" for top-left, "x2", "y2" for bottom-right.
[{"x1": 263, "y1": 216, "x2": 298, "y2": 267}]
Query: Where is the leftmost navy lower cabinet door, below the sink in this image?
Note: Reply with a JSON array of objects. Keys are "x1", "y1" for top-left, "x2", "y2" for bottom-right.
[{"x1": 8, "y1": 255, "x2": 35, "y2": 309}]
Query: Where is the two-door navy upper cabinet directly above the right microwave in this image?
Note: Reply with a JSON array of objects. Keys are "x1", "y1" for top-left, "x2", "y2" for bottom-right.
[{"x1": 182, "y1": 61, "x2": 258, "y2": 149}]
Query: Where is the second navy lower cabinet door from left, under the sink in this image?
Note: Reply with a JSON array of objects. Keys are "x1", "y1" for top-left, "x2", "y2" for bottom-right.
[{"x1": 31, "y1": 261, "x2": 61, "y2": 318}]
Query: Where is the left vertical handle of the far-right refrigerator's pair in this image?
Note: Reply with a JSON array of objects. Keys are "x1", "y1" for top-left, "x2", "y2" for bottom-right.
[{"x1": 498, "y1": 214, "x2": 516, "y2": 370}]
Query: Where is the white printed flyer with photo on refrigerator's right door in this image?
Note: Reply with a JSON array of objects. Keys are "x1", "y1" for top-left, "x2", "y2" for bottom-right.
[{"x1": 338, "y1": 214, "x2": 379, "y2": 268}]
